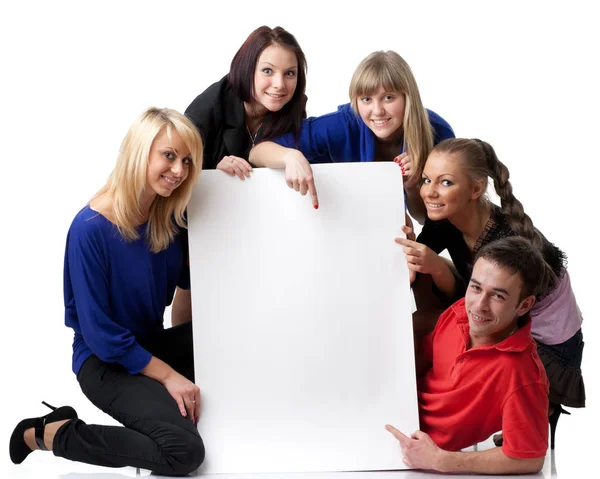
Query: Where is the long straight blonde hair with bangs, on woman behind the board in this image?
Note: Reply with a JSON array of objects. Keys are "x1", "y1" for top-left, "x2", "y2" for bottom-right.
[{"x1": 349, "y1": 50, "x2": 433, "y2": 178}]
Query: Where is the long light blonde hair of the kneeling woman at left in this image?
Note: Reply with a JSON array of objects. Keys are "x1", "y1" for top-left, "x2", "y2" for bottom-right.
[{"x1": 94, "y1": 107, "x2": 202, "y2": 253}]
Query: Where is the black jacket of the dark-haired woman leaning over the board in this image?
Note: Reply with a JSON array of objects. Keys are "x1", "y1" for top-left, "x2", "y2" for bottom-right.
[{"x1": 185, "y1": 76, "x2": 262, "y2": 170}]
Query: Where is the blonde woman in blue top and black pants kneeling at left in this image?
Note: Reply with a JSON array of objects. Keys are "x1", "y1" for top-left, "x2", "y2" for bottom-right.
[{"x1": 10, "y1": 108, "x2": 204, "y2": 475}]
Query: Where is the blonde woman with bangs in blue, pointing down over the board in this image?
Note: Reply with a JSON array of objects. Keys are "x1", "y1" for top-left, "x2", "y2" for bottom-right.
[{"x1": 250, "y1": 51, "x2": 454, "y2": 222}]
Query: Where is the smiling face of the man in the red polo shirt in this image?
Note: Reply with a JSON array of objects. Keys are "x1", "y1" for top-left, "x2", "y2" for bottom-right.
[{"x1": 465, "y1": 258, "x2": 535, "y2": 346}]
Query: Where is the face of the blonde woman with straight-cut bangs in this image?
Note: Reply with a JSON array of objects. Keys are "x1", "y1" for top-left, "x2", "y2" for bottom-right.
[{"x1": 357, "y1": 87, "x2": 406, "y2": 142}]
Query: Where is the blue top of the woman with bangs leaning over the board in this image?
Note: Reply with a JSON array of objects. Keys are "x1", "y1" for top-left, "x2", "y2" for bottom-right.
[{"x1": 273, "y1": 103, "x2": 454, "y2": 163}]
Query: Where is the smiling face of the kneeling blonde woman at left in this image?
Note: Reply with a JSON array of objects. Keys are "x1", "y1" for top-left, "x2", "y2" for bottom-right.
[{"x1": 146, "y1": 128, "x2": 192, "y2": 201}]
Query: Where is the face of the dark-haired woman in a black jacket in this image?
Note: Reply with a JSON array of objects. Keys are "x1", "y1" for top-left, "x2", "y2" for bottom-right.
[{"x1": 254, "y1": 45, "x2": 298, "y2": 114}]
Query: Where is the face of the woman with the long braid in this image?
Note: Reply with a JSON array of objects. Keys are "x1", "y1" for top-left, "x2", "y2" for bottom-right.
[{"x1": 421, "y1": 152, "x2": 481, "y2": 221}]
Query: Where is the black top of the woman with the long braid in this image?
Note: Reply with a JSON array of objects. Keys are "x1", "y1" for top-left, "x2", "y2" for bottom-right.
[{"x1": 417, "y1": 205, "x2": 566, "y2": 299}]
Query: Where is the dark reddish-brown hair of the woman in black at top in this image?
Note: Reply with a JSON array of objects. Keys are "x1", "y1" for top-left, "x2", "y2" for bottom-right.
[{"x1": 227, "y1": 26, "x2": 306, "y2": 141}]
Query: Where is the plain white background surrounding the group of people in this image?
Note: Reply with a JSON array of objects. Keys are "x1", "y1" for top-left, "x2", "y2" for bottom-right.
[{"x1": 0, "y1": 0, "x2": 600, "y2": 477}]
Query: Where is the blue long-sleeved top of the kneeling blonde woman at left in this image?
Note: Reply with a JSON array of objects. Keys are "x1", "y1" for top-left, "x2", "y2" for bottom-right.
[{"x1": 64, "y1": 206, "x2": 190, "y2": 374}]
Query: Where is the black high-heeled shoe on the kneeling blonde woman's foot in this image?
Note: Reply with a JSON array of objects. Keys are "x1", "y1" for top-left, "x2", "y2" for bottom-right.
[{"x1": 10, "y1": 401, "x2": 77, "y2": 464}]
